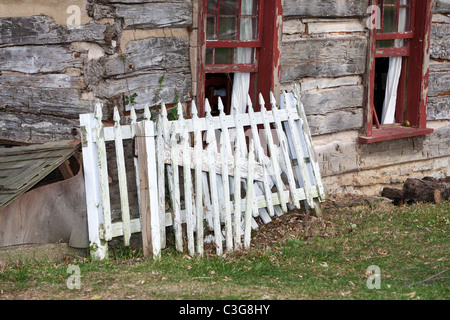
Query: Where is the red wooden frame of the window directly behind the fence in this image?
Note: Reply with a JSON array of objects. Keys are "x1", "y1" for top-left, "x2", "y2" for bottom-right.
[{"x1": 196, "y1": 0, "x2": 283, "y2": 116}]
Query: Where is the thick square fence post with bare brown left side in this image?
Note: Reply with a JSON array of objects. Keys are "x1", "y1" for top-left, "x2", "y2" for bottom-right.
[{"x1": 136, "y1": 120, "x2": 161, "y2": 258}]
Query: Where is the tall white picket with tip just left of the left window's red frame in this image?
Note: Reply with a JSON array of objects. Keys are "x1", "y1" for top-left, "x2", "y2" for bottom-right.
[{"x1": 191, "y1": 101, "x2": 204, "y2": 256}]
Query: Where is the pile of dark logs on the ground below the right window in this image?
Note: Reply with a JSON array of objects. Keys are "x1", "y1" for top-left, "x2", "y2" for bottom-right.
[{"x1": 381, "y1": 177, "x2": 450, "y2": 204}]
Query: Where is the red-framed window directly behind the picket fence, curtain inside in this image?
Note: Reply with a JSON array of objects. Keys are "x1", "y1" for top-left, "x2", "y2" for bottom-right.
[{"x1": 197, "y1": 0, "x2": 282, "y2": 115}]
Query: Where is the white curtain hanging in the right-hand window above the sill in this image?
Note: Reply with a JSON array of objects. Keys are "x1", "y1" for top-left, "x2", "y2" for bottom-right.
[{"x1": 381, "y1": 0, "x2": 408, "y2": 124}]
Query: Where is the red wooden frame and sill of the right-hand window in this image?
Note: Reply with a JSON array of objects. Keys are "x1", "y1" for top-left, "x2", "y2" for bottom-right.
[{"x1": 359, "y1": 0, "x2": 433, "y2": 143}]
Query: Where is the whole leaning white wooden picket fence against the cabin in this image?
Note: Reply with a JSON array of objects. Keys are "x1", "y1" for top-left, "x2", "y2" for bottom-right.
[{"x1": 80, "y1": 88, "x2": 325, "y2": 259}]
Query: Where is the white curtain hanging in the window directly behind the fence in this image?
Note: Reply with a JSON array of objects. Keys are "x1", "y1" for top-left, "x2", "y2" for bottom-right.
[{"x1": 230, "y1": 0, "x2": 254, "y2": 114}]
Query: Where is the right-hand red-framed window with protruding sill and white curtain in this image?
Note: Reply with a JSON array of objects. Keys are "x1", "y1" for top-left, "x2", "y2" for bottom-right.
[{"x1": 359, "y1": 0, "x2": 433, "y2": 143}]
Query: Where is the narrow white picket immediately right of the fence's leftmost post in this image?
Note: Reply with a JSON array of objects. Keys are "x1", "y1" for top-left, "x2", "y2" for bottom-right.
[{"x1": 94, "y1": 103, "x2": 112, "y2": 241}]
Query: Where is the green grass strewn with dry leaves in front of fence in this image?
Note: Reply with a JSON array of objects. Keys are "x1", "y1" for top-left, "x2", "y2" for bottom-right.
[{"x1": 0, "y1": 202, "x2": 450, "y2": 300}]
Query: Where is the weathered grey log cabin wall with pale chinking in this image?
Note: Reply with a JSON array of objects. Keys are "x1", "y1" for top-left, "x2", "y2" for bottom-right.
[{"x1": 0, "y1": 0, "x2": 450, "y2": 199}]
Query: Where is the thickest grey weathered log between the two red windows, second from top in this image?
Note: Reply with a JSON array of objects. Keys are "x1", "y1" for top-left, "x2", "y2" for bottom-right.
[{"x1": 281, "y1": 36, "x2": 367, "y2": 83}]
